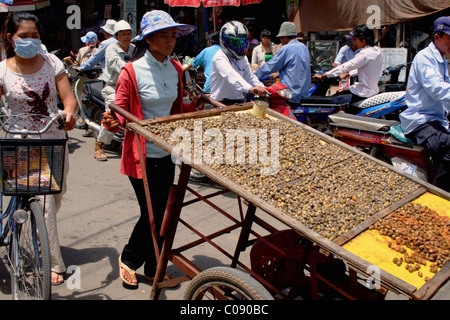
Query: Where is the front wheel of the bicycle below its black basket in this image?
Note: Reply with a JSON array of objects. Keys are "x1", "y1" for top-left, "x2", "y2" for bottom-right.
[{"x1": 10, "y1": 200, "x2": 51, "y2": 300}]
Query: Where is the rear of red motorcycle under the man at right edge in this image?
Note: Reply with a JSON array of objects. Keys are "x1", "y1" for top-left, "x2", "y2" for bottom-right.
[{"x1": 329, "y1": 112, "x2": 436, "y2": 182}]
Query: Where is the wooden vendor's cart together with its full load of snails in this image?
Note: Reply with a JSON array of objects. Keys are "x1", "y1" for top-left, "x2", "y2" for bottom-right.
[{"x1": 112, "y1": 103, "x2": 450, "y2": 299}]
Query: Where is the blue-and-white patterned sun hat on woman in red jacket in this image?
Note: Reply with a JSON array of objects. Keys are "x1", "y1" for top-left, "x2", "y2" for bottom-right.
[{"x1": 136, "y1": 10, "x2": 197, "y2": 40}]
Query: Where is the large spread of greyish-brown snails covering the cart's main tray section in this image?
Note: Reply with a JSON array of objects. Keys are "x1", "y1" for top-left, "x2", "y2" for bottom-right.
[{"x1": 147, "y1": 112, "x2": 420, "y2": 240}]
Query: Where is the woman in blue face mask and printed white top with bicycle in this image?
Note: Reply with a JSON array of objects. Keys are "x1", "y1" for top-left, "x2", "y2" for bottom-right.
[{"x1": 0, "y1": 12, "x2": 77, "y2": 285}]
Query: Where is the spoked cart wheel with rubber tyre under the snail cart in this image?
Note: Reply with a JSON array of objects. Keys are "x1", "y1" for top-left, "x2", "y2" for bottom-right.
[{"x1": 184, "y1": 267, "x2": 273, "y2": 300}]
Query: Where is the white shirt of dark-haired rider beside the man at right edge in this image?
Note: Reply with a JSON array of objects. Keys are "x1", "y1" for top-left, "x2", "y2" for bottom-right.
[{"x1": 325, "y1": 46, "x2": 383, "y2": 98}]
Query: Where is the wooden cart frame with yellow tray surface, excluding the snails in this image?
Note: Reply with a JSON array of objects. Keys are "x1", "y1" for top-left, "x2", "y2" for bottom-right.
[{"x1": 111, "y1": 103, "x2": 450, "y2": 299}]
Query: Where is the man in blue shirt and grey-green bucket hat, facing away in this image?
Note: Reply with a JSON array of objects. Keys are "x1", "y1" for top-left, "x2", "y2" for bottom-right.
[{"x1": 254, "y1": 21, "x2": 311, "y2": 104}]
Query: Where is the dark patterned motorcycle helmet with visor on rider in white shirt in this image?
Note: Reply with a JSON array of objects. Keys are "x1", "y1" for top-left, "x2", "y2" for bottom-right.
[{"x1": 219, "y1": 21, "x2": 250, "y2": 60}]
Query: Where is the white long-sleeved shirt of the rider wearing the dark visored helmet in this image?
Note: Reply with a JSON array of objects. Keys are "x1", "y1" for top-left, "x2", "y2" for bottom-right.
[{"x1": 211, "y1": 49, "x2": 264, "y2": 101}]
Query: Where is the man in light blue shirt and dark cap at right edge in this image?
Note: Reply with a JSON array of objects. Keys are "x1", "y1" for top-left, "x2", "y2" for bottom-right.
[{"x1": 400, "y1": 16, "x2": 450, "y2": 192}]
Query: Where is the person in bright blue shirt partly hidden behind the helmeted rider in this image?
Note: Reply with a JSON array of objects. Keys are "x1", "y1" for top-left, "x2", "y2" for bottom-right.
[{"x1": 183, "y1": 32, "x2": 220, "y2": 94}]
